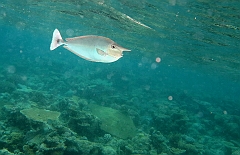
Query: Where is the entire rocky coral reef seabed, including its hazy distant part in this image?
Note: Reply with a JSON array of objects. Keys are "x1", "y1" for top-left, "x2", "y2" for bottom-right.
[{"x1": 0, "y1": 56, "x2": 240, "y2": 155}]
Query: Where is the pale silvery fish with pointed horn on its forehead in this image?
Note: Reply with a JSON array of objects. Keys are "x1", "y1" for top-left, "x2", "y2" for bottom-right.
[{"x1": 50, "y1": 29, "x2": 131, "y2": 63}]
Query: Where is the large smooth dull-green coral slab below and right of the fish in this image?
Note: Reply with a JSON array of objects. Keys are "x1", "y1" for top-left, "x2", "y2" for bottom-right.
[{"x1": 88, "y1": 104, "x2": 136, "y2": 139}]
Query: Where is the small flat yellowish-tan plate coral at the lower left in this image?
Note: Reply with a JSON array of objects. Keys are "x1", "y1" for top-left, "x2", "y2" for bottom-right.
[{"x1": 20, "y1": 108, "x2": 60, "y2": 123}]
